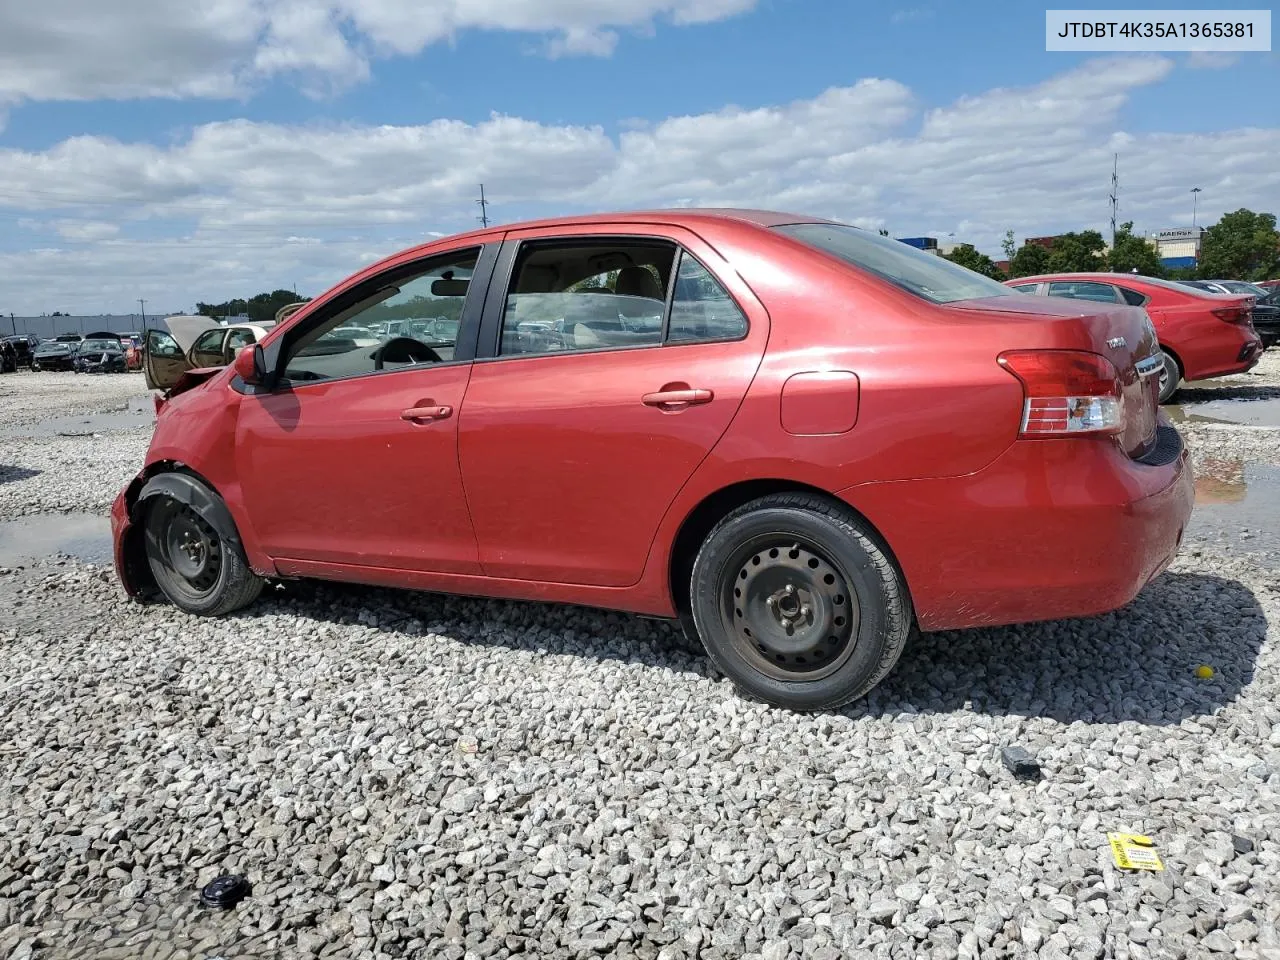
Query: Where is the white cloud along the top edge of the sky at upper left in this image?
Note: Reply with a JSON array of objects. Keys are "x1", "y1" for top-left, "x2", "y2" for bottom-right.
[{"x1": 0, "y1": 0, "x2": 755, "y2": 108}]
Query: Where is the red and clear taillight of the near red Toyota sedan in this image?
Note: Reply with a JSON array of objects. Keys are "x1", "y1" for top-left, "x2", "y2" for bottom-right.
[{"x1": 998, "y1": 349, "x2": 1124, "y2": 438}]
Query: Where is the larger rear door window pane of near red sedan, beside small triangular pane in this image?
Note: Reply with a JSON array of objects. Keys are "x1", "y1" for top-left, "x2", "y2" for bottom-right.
[{"x1": 498, "y1": 239, "x2": 676, "y2": 356}]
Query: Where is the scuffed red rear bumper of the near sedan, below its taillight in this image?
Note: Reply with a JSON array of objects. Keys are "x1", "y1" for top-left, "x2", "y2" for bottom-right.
[{"x1": 840, "y1": 419, "x2": 1194, "y2": 630}]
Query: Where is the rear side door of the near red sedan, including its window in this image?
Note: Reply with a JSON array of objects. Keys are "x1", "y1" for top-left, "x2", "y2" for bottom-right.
[{"x1": 458, "y1": 227, "x2": 768, "y2": 586}]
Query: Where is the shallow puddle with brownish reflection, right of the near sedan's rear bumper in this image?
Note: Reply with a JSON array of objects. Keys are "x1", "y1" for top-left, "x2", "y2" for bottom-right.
[{"x1": 1188, "y1": 460, "x2": 1280, "y2": 550}]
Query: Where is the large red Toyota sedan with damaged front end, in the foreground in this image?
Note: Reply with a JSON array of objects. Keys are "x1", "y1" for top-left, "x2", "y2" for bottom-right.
[{"x1": 113, "y1": 210, "x2": 1192, "y2": 709}]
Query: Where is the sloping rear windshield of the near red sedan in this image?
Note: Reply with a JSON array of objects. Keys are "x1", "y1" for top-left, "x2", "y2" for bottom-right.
[{"x1": 774, "y1": 223, "x2": 1014, "y2": 303}]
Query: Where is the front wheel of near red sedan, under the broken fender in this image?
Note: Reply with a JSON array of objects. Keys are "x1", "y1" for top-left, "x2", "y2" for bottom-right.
[{"x1": 146, "y1": 497, "x2": 262, "y2": 617}]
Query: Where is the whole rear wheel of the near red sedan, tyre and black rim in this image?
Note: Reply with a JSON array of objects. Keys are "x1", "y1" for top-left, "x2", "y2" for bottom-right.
[{"x1": 690, "y1": 494, "x2": 911, "y2": 710}]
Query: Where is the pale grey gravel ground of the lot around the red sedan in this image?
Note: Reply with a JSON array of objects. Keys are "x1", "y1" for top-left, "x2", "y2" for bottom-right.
[{"x1": 0, "y1": 363, "x2": 1280, "y2": 960}]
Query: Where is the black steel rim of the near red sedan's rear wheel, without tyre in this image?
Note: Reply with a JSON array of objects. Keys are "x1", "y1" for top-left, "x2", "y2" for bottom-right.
[{"x1": 718, "y1": 534, "x2": 859, "y2": 680}]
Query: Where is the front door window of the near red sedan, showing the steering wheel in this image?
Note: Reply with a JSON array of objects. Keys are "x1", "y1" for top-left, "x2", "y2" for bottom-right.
[{"x1": 284, "y1": 247, "x2": 480, "y2": 381}]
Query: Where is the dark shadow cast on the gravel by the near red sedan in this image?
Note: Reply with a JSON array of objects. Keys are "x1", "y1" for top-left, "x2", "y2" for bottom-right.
[{"x1": 254, "y1": 573, "x2": 1267, "y2": 724}]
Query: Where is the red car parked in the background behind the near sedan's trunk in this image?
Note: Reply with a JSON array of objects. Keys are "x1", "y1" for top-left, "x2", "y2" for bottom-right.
[{"x1": 1005, "y1": 274, "x2": 1263, "y2": 402}]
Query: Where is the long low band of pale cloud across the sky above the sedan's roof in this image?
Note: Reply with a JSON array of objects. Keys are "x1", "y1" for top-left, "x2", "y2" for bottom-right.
[{"x1": 0, "y1": 58, "x2": 1280, "y2": 312}]
